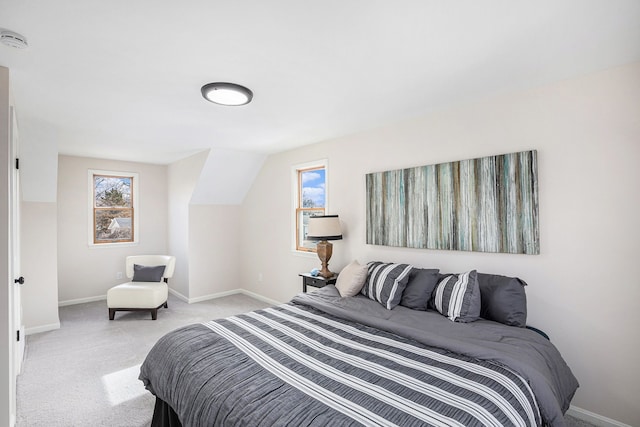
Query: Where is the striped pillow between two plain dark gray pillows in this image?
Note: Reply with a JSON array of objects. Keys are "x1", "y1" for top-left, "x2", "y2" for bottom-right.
[{"x1": 433, "y1": 270, "x2": 481, "y2": 323}]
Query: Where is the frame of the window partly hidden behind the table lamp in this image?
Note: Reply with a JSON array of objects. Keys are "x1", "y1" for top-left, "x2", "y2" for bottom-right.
[{"x1": 291, "y1": 159, "x2": 329, "y2": 255}]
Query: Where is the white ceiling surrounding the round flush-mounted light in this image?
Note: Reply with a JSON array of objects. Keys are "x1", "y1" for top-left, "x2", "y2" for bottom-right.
[{"x1": 0, "y1": 0, "x2": 640, "y2": 164}]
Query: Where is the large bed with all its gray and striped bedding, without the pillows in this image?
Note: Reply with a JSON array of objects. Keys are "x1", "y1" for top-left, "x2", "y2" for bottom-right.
[{"x1": 140, "y1": 268, "x2": 578, "y2": 427}]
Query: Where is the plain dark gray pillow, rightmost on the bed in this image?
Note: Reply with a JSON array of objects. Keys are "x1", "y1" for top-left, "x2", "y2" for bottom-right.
[{"x1": 478, "y1": 273, "x2": 527, "y2": 328}]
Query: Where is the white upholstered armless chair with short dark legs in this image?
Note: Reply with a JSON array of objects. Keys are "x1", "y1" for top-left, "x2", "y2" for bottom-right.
[{"x1": 107, "y1": 255, "x2": 176, "y2": 320}]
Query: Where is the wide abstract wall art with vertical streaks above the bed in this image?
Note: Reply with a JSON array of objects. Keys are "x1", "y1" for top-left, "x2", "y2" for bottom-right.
[{"x1": 366, "y1": 150, "x2": 540, "y2": 254}]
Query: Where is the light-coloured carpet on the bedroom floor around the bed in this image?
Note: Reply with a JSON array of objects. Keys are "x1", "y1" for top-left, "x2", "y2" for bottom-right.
[{"x1": 17, "y1": 295, "x2": 591, "y2": 427}]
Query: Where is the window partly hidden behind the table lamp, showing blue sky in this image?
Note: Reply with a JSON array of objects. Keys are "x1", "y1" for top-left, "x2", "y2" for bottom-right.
[{"x1": 293, "y1": 161, "x2": 327, "y2": 252}]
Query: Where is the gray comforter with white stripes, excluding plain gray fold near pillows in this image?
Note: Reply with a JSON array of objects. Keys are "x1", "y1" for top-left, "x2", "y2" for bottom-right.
[{"x1": 140, "y1": 291, "x2": 576, "y2": 426}]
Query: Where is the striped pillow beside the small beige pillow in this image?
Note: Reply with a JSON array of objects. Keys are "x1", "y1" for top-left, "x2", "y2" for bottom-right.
[{"x1": 361, "y1": 261, "x2": 412, "y2": 310}]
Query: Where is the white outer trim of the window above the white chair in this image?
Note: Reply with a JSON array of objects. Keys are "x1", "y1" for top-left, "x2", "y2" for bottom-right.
[{"x1": 87, "y1": 169, "x2": 140, "y2": 248}]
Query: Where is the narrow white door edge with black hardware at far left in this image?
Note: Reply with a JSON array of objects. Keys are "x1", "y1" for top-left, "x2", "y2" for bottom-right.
[{"x1": 9, "y1": 107, "x2": 25, "y2": 376}]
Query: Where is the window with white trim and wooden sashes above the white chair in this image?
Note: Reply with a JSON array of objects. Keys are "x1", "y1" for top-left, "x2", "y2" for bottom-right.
[{"x1": 89, "y1": 170, "x2": 138, "y2": 245}]
